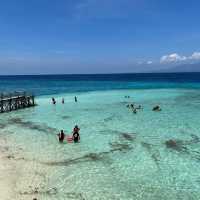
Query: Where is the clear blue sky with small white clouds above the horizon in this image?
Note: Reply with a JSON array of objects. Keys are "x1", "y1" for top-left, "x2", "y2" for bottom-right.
[{"x1": 0, "y1": 0, "x2": 200, "y2": 74}]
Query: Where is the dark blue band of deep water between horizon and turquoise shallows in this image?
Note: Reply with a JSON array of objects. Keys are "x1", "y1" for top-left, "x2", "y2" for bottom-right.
[{"x1": 0, "y1": 73, "x2": 200, "y2": 95}]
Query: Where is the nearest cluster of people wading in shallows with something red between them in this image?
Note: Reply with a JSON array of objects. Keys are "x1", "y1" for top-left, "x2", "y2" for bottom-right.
[{"x1": 57, "y1": 125, "x2": 80, "y2": 143}]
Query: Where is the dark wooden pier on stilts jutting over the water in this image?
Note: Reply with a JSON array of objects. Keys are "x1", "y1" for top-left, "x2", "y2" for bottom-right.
[{"x1": 0, "y1": 92, "x2": 35, "y2": 113}]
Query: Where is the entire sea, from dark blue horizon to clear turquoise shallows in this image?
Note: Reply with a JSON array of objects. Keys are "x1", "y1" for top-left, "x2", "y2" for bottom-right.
[{"x1": 0, "y1": 73, "x2": 200, "y2": 200}]
